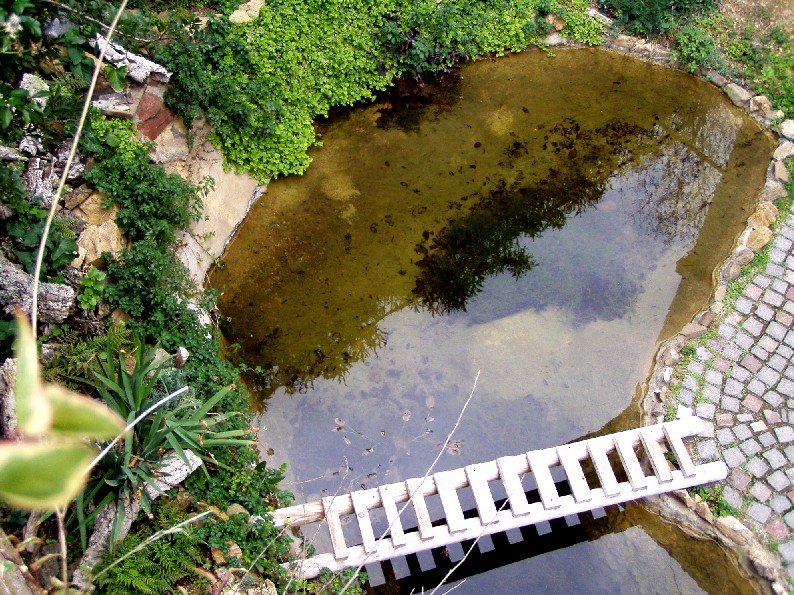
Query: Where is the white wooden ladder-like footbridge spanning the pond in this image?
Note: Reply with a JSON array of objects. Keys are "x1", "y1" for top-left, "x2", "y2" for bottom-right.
[{"x1": 272, "y1": 416, "x2": 728, "y2": 578}]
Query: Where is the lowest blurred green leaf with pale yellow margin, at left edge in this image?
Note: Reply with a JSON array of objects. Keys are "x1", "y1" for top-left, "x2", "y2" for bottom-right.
[{"x1": 0, "y1": 442, "x2": 93, "y2": 510}]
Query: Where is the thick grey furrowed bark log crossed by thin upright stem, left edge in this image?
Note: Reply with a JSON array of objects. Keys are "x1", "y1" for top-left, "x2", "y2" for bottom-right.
[{"x1": 0, "y1": 254, "x2": 75, "y2": 324}]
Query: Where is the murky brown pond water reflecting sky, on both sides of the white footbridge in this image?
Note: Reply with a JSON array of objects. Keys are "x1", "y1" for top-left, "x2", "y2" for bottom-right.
[{"x1": 211, "y1": 49, "x2": 772, "y2": 593}]
